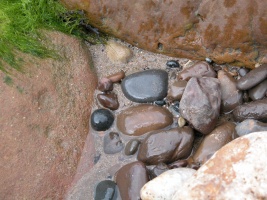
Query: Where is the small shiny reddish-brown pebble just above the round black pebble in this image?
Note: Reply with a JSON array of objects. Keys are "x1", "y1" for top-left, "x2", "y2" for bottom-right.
[{"x1": 96, "y1": 93, "x2": 119, "y2": 110}]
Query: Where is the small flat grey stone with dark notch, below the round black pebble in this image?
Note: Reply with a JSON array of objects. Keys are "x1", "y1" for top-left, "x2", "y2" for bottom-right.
[{"x1": 103, "y1": 132, "x2": 124, "y2": 154}]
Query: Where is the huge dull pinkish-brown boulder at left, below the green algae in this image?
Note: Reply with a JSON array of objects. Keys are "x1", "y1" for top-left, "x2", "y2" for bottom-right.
[{"x1": 0, "y1": 32, "x2": 97, "y2": 199}]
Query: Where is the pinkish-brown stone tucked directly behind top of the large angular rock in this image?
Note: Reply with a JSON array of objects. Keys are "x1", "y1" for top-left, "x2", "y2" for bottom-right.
[{"x1": 177, "y1": 61, "x2": 216, "y2": 81}]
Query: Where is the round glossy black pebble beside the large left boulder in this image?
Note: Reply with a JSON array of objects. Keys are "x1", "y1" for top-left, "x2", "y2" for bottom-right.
[{"x1": 91, "y1": 108, "x2": 114, "y2": 131}]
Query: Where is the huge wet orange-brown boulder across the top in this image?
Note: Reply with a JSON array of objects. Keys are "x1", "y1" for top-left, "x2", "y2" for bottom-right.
[{"x1": 61, "y1": 0, "x2": 267, "y2": 67}]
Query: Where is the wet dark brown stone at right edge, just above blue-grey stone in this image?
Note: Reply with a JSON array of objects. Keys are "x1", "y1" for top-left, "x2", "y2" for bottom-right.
[{"x1": 233, "y1": 99, "x2": 267, "y2": 122}]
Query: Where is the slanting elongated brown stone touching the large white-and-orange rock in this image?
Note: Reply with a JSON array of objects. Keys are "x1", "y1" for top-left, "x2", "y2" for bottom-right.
[{"x1": 193, "y1": 122, "x2": 236, "y2": 166}]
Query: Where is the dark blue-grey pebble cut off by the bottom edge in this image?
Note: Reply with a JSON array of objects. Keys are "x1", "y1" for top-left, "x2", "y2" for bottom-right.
[{"x1": 94, "y1": 180, "x2": 118, "y2": 200}]
